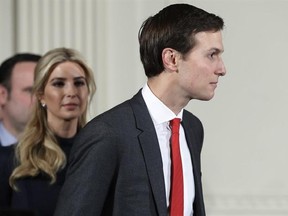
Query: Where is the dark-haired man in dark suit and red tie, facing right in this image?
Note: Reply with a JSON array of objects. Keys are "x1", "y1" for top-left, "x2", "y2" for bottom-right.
[{"x1": 55, "y1": 4, "x2": 226, "y2": 216}]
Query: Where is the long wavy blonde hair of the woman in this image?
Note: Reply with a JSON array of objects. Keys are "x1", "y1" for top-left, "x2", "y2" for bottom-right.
[{"x1": 9, "y1": 48, "x2": 96, "y2": 190}]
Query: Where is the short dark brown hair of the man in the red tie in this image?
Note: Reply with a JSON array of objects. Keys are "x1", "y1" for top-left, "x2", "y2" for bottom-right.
[{"x1": 138, "y1": 4, "x2": 224, "y2": 77}]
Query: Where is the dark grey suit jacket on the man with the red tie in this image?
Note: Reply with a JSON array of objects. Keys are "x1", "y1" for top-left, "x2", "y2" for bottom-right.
[{"x1": 54, "y1": 91, "x2": 205, "y2": 216}]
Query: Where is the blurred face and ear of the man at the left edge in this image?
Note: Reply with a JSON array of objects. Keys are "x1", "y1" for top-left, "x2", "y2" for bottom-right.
[{"x1": 0, "y1": 62, "x2": 36, "y2": 138}]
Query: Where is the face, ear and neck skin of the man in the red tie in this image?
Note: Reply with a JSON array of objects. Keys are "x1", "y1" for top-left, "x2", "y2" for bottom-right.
[{"x1": 148, "y1": 31, "x2": 226, "y2": 115}]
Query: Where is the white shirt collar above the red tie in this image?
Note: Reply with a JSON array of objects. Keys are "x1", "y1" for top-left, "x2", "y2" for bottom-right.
[{"x1": 142, "y1": 83, "x2": 183, "y2": 124}]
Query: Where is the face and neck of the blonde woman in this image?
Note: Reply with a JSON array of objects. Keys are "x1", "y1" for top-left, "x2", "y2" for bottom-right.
[{"x1": 39, "y1": 62, "x2": 89, "y2": 138}]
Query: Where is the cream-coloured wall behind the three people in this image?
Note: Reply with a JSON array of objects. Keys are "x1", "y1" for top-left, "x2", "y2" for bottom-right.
[{"x1": 0, "y1": 0, "x2": 288, "y2": 216}]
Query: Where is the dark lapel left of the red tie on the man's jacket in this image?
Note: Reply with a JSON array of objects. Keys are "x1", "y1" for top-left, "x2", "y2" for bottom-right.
[{"x1": 130, "y1": 90, "x2": 167, "y2": 216}]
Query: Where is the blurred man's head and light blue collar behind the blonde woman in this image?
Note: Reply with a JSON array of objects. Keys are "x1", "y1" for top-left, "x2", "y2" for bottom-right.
[{"x1": 0, "y1": 53, "x2": 41, "y2": 146}]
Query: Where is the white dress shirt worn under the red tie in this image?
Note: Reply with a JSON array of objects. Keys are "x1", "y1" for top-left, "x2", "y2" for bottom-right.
[{"x1": 142, "y1": 83, "x2": 195, "y2": 216}]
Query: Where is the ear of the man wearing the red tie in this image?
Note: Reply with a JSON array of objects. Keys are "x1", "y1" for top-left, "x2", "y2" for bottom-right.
[{"x1": 162, "y1": 48, "x2": 179, "y2": 71}]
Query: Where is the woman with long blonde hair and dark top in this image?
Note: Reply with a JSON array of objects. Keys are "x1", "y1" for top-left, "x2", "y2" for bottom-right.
[{"x1": 5, "y1": 48, "x2": 96, "y2": 216}]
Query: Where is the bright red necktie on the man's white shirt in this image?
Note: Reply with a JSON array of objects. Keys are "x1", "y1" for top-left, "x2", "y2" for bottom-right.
[{"x1": 170, "y1": 118, "x2": 184, "y2": 216}]
